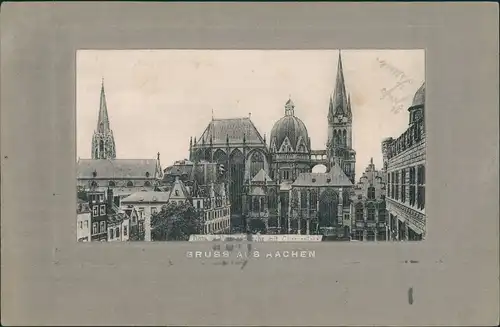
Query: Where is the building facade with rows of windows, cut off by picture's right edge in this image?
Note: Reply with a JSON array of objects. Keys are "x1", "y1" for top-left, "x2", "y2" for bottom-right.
[{"x1": 382, "y1": 83, "x2": 427, "y2": 241}]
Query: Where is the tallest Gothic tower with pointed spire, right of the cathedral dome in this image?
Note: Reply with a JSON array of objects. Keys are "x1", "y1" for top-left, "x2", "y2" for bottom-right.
[{"x1": 327, "y1": 51, "x2": 356, "y2": 184}]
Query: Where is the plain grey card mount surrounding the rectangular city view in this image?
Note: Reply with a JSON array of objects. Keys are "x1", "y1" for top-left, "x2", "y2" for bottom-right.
[{"x1": 1, "y1": 2, "x2": 499, "y2": 326}]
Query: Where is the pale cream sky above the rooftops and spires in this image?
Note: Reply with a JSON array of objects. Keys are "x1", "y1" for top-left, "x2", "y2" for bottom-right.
[{"x1": 77, "y1": 50, "x2": 425, "y2": 178}]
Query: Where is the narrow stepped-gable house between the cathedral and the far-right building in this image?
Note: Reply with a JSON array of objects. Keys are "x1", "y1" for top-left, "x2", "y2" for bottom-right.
[{"x1": 350, "y1": 158, "x2": 388, "y2": 241}]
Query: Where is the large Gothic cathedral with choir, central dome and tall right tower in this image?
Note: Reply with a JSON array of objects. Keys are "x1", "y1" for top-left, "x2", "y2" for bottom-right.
[{"x1": 189, "y1": 53, "x2": 356, "y2": 237}]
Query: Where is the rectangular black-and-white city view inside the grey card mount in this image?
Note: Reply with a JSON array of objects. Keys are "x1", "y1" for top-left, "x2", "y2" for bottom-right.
[{"x1": 75, "y1": 49, "x2": 426, "y2": 242}]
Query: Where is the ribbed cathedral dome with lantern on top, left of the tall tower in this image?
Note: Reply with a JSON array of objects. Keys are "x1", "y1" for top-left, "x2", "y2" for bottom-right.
[{"x1": 271, "y1": 99, "x2": 309, "y2": 152}]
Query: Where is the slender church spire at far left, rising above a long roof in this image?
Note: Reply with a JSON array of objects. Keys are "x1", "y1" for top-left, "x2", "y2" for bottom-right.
[{"x1": 92, "y1": 81, "x2": 116, "y2": 159}]
